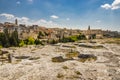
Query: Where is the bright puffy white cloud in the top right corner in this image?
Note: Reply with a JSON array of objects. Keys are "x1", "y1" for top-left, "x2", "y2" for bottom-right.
[{"x1": 101, "y1": 0, "x2": 120, "y2": 10}]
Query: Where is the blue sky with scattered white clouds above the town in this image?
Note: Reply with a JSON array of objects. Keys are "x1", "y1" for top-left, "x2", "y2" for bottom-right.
[{"x1": 0, "y1": 0, "x2": 120, "y2": 31}]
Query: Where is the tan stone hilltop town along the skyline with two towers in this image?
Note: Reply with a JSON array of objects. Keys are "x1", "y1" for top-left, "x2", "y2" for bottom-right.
[{"x1": 0, "y1": 19, "x2": 120, "y2": 40}]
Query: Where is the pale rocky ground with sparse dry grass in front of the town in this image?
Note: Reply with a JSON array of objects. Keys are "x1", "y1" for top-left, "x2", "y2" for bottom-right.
[{"x1": 0, "y1": 39, "x2": 120, "y2": 80}]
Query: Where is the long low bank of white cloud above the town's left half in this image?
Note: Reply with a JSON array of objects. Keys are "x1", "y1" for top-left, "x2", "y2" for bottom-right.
[{"x1": 0, "y1": 13, "x2": 66, "y2": 28}]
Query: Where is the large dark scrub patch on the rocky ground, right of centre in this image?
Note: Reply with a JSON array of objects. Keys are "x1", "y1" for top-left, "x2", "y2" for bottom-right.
[{"x1": 78, "y1": 54, "x2": 97, "y2": 62}]
